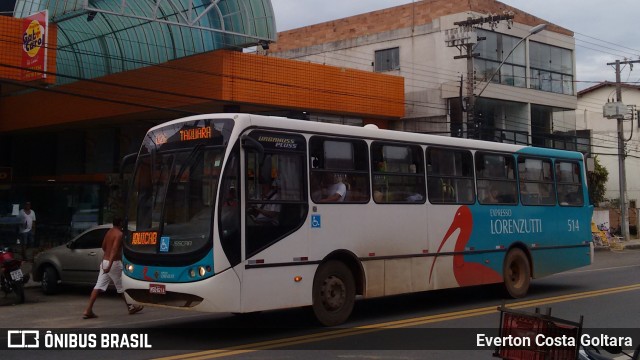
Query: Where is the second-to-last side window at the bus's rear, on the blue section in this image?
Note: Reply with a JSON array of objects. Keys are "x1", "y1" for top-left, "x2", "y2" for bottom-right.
[{"x1": 518, "y1": 156, "x2": 556, "y2": 206}]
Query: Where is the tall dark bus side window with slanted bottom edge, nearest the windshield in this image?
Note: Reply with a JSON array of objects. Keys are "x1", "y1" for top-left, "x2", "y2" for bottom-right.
[{"x1": 245, "y1": 131, "x2": 308, "y2": 258}]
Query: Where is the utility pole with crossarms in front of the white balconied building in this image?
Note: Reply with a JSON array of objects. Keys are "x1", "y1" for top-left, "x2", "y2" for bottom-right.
[{"x1": 445, "y1": 14, "x2": 513, "y2": 138}]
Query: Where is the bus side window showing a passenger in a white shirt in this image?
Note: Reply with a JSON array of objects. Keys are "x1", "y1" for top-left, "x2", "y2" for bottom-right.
[{"x1": 309, "y1": 136, "x2": 370, "y2": 203}]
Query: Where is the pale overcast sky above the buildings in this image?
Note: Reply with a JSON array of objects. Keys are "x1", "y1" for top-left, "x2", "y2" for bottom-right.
[{"x1": 271, "y1": 0, "x2": 640, "y2": 90}]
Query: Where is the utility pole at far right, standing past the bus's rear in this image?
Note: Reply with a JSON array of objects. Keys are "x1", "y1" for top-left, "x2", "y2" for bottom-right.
[{"x1": 604, "y1": 60, "x2": 640, "y2": 240}]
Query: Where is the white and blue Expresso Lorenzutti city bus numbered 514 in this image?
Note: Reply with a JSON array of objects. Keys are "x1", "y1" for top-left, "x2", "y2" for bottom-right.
[{"x1": 123, "y1": 114, "x2": 593, "y2": 326}]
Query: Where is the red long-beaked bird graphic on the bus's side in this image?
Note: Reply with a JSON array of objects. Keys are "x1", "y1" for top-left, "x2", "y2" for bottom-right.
[{"x1": 429, "y1": 205, "x2": 502, "y2": 286}]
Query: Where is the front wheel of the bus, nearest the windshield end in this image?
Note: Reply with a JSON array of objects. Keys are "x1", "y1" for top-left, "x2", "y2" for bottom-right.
[{"x1": 312, "y1": 260, "x2": 356, "y2": 326}]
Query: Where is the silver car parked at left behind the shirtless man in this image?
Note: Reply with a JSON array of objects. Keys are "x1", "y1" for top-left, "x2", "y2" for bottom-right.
[{"x1": 32, "y1": 224, "x2": 112, "y2": 294}]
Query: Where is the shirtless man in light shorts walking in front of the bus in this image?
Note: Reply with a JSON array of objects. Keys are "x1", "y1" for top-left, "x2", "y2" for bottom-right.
[{"x1": 82, "y1": 218, "x2": 143, "y2": 319}]
